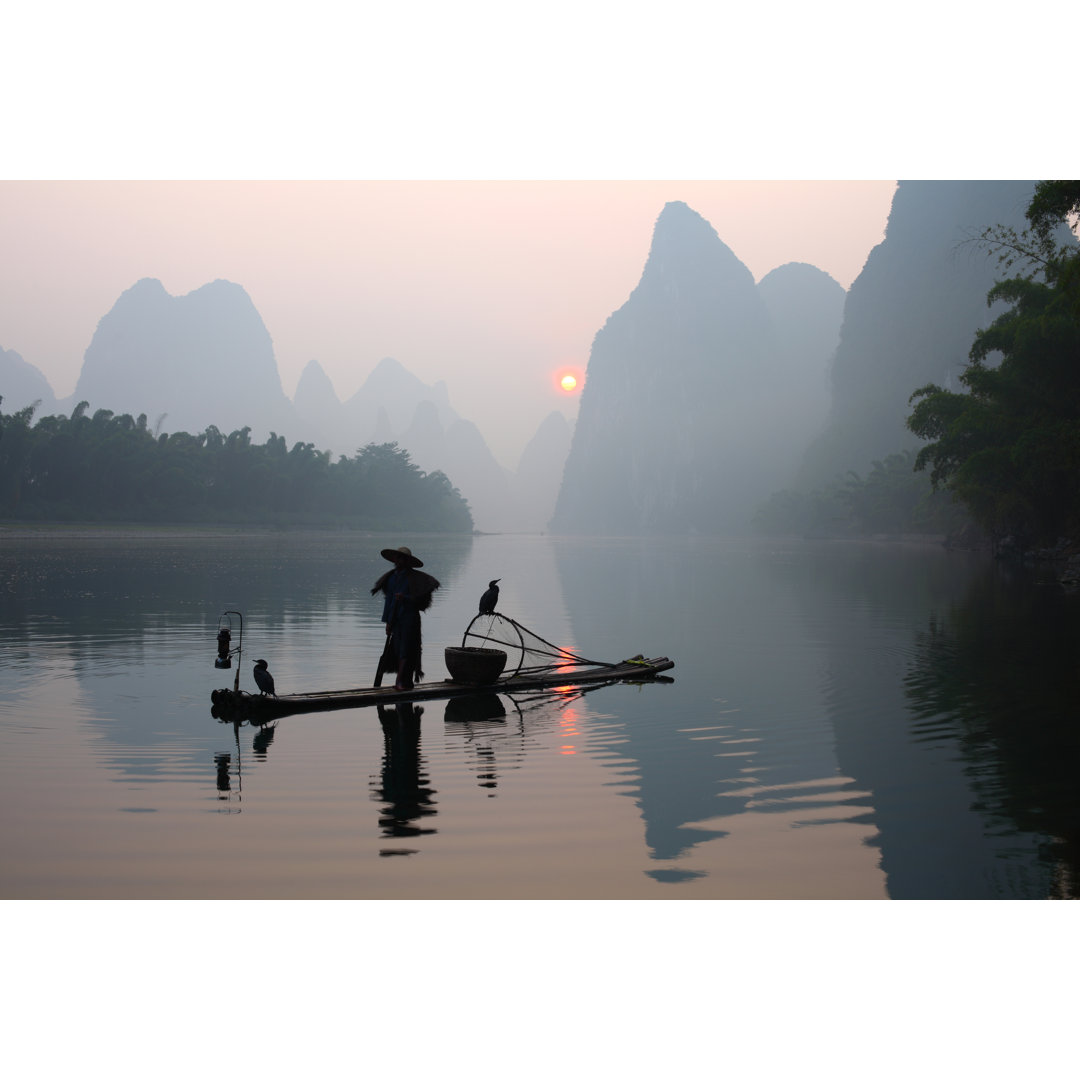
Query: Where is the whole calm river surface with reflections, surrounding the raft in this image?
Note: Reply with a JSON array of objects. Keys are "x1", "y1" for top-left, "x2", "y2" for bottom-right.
[{"x1": 0, "y1": 532, "x2": 1080, "y2": 900}]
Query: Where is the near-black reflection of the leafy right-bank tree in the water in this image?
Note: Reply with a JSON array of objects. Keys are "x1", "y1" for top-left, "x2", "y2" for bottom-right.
[{"x1": 906, "y1": 566, "x2": 1080, "y2": 899}]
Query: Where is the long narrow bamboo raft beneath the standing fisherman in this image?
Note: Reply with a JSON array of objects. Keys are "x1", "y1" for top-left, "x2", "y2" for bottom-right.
[{"x1": 211, "y1": 656, "x2": 675, "y2": 724}]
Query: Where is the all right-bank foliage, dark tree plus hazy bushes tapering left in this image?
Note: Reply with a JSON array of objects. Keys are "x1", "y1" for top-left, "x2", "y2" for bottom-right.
[{"x1": 755, "y1": 180, "x2": 1080, "y2": 559}]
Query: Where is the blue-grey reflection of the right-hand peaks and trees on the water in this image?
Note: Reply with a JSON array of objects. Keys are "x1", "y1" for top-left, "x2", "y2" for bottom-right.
[{"x1": 556, "y1": 540, "x2": 1080, "y2": 899}]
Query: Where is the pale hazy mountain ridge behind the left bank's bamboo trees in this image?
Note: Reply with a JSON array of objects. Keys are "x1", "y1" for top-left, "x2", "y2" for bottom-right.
[{"x1": 0, "y1": 278, "x2": 565, "y2": 531}]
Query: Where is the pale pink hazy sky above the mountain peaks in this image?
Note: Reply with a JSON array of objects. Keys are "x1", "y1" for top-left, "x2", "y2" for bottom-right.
[{"x1": 0, "y1": 180, "x2": 894, "y2": 467}]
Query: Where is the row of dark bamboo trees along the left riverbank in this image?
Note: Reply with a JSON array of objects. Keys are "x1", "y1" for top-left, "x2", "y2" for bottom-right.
[{"x1": 0, "y1": 399, "x2": 473, "y2": 532}]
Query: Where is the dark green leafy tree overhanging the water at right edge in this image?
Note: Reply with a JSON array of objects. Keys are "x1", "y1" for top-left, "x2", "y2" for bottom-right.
[{"x1": 907, "y1": 180, "x2": 1080, "y2": 551}]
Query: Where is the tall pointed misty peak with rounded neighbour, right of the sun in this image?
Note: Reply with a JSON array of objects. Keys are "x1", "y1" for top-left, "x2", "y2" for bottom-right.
[{"x1": 552, "y1": 202, "x2": 842, "y2": 535}]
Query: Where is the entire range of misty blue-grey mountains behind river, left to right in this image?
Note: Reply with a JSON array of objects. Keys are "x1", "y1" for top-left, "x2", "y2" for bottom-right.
[{"x1": 10, "y1": 187, "x2": 1034, "y2": 535}]
